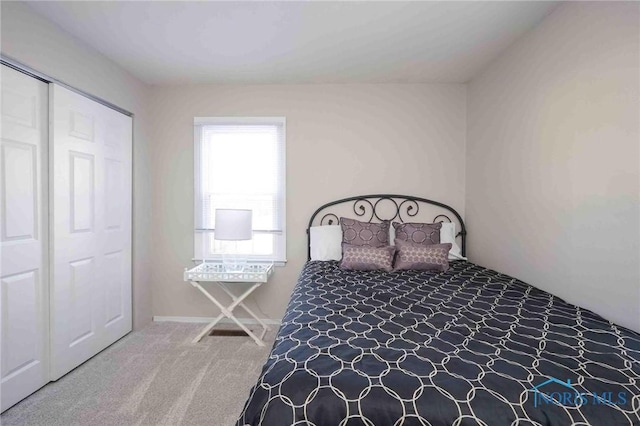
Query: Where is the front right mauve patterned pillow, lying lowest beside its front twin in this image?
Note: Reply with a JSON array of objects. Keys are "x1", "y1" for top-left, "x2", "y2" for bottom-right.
[{"x1": 393, "y1": 238, "x2": 451, "y2": 272}]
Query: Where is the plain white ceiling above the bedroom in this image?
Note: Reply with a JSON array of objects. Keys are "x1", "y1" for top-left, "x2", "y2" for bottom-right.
[{"x1": 29, "y1": 1, "x2": 558, "y2": 84}]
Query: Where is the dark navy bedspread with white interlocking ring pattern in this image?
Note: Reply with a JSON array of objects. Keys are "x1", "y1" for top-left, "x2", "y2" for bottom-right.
[{"x1": 237, "y1": 261, "x2": 640, "y2": 426}]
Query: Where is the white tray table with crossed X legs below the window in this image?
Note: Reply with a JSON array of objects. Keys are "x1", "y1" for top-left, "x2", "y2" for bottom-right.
[{"x1": 184, "y1": 262, "x2": 273, "y2": 346}]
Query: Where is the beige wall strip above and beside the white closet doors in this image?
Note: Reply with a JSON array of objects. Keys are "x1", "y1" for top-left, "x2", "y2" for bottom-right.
[{"x1": 0, "y1": 1, "x2": 151, "y2": 328}]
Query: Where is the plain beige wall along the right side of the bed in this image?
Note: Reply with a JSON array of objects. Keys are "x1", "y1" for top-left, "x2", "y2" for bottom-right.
[{"x1": 466, "y1": 2, "x2": 640, "y2": 331}]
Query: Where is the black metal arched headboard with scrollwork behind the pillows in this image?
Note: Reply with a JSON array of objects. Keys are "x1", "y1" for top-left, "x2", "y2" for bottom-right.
[{"x1": 307, "y1": 194, "x2": 467, "y2": 259}]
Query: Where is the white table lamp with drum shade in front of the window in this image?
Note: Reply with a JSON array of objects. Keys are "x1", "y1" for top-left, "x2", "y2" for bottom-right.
[{"x1": 213, "y1": 209, "x2": 253, "y2": 272}]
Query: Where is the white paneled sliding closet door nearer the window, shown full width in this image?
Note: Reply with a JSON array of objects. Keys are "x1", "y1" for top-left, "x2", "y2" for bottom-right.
[{"x1": 49, "y1": 84, "x2": 132, "y2": 380}]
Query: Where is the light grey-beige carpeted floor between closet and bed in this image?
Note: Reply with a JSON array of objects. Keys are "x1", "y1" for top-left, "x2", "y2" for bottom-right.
[{"x1": 0, "y1": 322, "x2": 276, "y2": 426}]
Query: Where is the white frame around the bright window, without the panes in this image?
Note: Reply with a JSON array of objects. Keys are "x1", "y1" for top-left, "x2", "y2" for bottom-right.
[{"x1": 193, "y1": 117, "x2": 287, "y2": 266}]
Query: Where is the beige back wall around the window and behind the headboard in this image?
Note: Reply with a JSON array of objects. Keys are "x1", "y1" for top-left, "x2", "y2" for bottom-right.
[{"x1": 151, "y1": 84, "x2": 466, "y2": 320}]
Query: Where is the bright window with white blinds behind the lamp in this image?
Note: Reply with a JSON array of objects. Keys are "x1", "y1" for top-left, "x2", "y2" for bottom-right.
[{"x1": 194, "y1": 117, "x2": 286, "y2": 262}]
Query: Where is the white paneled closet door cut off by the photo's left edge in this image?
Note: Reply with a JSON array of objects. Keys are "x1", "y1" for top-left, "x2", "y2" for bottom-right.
[{"x1": 0, "y1": 65, "x2": 49, "y2": 411}]
